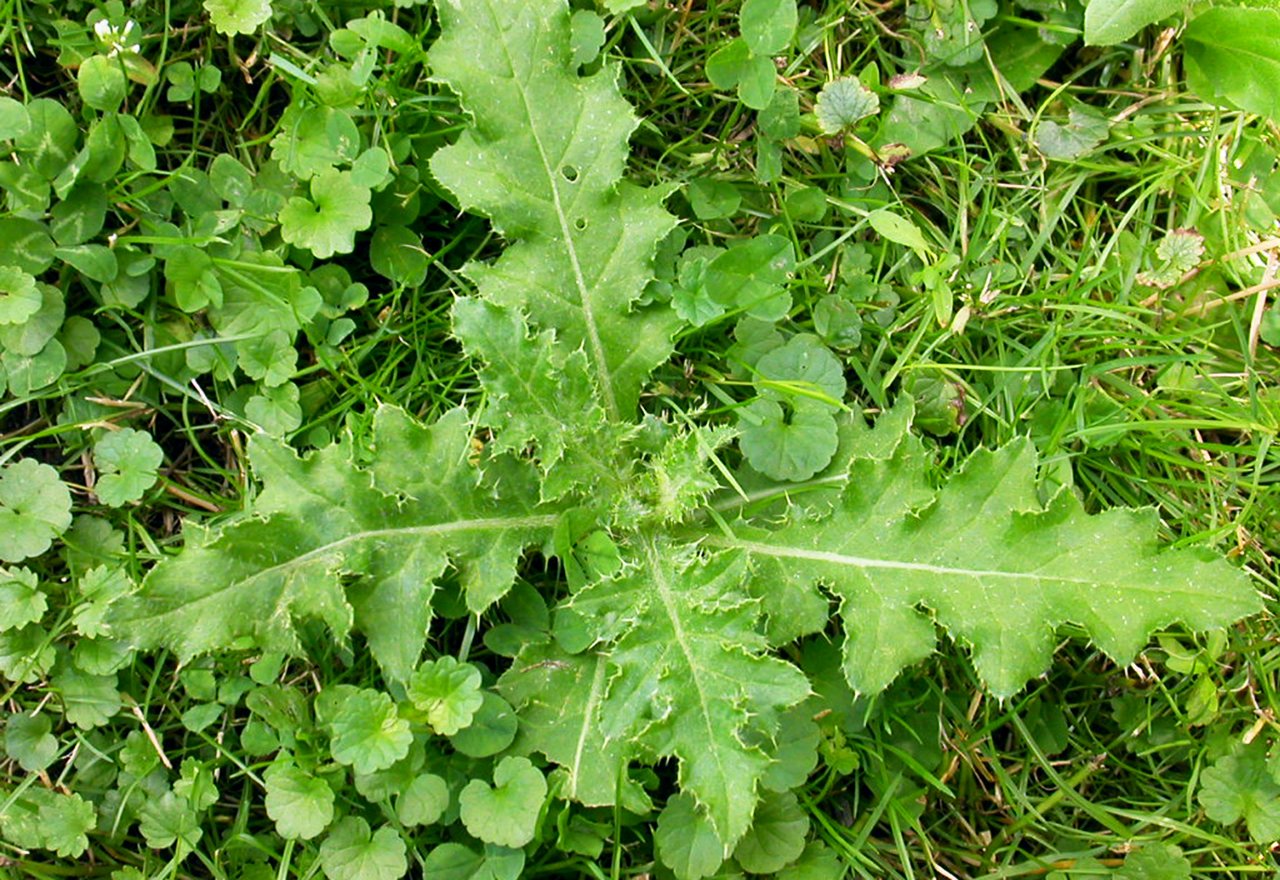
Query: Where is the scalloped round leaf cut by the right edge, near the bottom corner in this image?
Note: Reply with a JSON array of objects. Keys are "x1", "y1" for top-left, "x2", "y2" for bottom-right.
[{"x1": 1197, "y1": 738, "x2": 1280, "y2": 844}]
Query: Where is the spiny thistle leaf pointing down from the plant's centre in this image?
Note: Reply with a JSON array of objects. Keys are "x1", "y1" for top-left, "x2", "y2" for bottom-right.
[{"x1": 559, "y1": 540, "x2": 809, "y2": 847}]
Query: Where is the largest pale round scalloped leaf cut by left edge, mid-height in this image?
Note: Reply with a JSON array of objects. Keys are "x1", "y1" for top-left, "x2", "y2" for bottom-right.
[{"x1": 0, "y1": 458, "x2": 72, "y2": 563}]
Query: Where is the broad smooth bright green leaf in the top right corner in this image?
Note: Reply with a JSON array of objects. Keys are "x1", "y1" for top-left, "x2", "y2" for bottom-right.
[{"x1": 1179, "y1": 4, "x2": 1280, "y2": 122}]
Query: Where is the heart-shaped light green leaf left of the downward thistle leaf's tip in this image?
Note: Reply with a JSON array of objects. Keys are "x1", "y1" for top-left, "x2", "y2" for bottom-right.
[{"x1": 458, "y1": 756, "x2": 547, "y2": 848}]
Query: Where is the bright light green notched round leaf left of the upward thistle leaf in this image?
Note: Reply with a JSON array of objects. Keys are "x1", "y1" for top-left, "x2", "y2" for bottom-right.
[{"x1": 280, "y1": 169, "x2": 374, "y2": 260}]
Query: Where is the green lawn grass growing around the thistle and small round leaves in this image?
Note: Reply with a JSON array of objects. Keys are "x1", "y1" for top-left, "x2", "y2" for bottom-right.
[{"x1": 0, "y1": 3, "x2": 1280, "y2": 880}]
